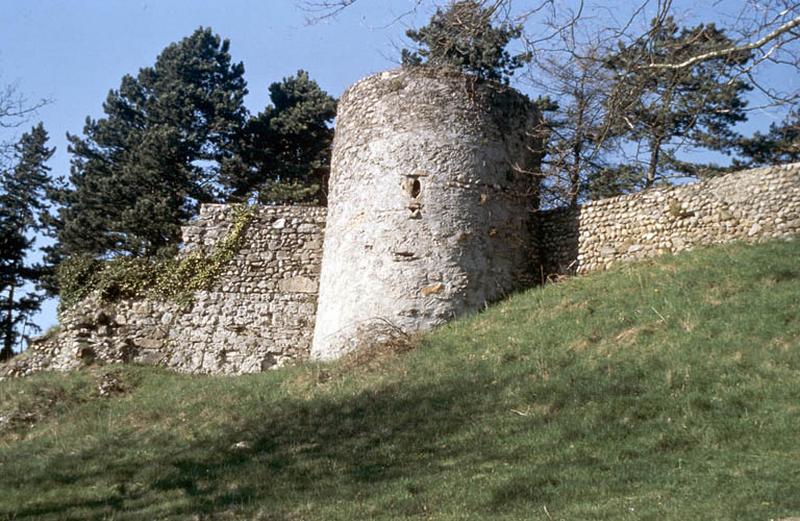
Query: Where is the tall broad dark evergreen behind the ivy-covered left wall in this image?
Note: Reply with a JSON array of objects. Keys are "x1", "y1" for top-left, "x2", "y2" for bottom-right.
[{"x1": 58, "y1": 28, "x2": 247, "y2": 256}]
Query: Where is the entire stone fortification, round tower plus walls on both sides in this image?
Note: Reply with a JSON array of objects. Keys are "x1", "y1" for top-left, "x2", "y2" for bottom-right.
[{"x1": 0, "y1": 70, "x2": 800, "y2": 378}]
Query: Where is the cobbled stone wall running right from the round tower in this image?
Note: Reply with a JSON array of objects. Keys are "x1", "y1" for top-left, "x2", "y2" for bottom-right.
[{"x1": 538, "y1": 163, "x2": 800, "y2": 275}]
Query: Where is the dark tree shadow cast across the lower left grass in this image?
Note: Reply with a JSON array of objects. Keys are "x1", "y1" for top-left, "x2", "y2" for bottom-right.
[{"x1": 0, "y1": 368, "x2": 532, "y2": 519}]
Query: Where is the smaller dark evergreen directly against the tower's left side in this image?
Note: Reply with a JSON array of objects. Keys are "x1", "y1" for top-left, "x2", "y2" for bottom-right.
[{"x1": 223, "y1": 70, "x2": 336, "y2": 204}]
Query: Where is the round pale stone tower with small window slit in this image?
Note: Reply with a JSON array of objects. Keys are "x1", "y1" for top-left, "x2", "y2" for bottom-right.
[{"x1": 311, "y1": 68, "x2": 541, "y2": 359}]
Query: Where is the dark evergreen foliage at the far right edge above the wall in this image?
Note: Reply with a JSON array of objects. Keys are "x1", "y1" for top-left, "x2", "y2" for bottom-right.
[{"x1": 737, "y1": 110, "x2": 800, "y2": 166}]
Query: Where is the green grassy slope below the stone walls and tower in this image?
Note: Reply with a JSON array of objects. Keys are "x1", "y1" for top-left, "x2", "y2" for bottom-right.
[{"x1": 0, "y1": 241, "x2": 800, "y2": 521}]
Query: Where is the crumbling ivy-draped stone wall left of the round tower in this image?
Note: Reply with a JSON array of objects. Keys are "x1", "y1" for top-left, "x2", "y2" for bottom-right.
[{"x1": 4, "y1": 205, "x2": 326, "y2": 374}]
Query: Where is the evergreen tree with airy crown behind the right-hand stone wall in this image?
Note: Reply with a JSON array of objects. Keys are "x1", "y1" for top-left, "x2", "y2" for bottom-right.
[{"x1": 607, "y1": 17, "x2": 751, "y2": 189}]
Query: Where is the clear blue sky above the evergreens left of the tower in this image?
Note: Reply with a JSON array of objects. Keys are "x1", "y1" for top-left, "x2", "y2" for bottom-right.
[{"x1": 0, "y1": 0, "x2": 798, "y2": 334}]
